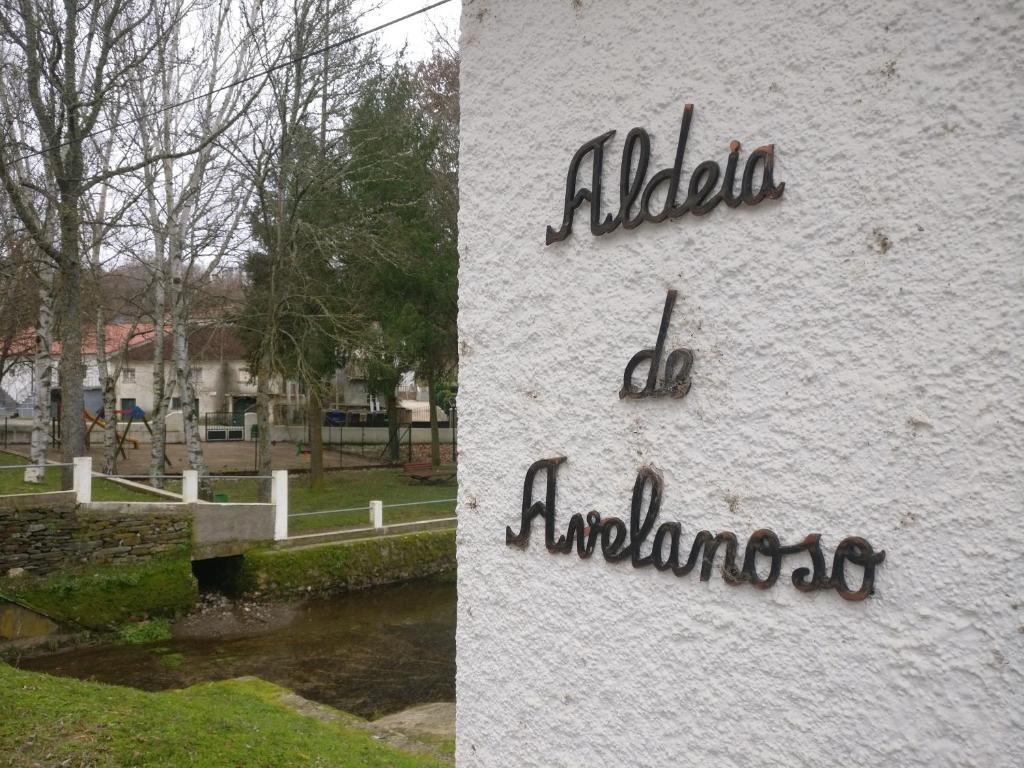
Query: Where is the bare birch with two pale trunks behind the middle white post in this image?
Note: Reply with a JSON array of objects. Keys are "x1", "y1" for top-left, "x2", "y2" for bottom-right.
[{"x1": 126, "y1": 0, "x2": 261, "y2": 489}]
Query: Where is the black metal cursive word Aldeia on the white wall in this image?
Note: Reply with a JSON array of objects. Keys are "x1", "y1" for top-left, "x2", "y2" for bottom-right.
[{"x1": 545, "y1": 104, "x2": 785, "y2": 246}]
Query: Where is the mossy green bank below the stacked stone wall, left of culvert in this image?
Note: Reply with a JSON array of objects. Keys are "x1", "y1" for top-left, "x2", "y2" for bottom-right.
[{"x1": 0, "y1": 551, "x2": 198, "y2": 629}]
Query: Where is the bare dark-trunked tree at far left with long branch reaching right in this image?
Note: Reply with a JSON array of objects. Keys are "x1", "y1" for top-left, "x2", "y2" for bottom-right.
[{"x1": 0, "y1": 0, "x2": 256, "y2": 481}]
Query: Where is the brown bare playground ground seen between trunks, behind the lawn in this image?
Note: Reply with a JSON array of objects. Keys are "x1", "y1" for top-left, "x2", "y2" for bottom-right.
[{"x1": 32, "y1": 442, "x2": 382, "y2": 475}]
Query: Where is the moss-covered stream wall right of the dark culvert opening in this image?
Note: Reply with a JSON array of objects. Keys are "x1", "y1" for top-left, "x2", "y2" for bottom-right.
[{"x1": 234, "y1": 530, "x2": 456, "y2": 597}]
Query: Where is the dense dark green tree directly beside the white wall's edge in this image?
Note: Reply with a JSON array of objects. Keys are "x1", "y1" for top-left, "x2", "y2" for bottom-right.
[{"x1": 345, "y1": 57, "x2": 459, "y2": 466}]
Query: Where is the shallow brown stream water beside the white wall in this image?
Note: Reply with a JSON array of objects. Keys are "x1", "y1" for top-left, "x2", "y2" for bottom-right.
[{"x1": 18, "y1": 582, "x2": 456, "y2": 718}]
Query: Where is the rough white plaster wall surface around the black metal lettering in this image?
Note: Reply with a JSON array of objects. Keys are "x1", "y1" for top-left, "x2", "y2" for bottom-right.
[{"x1": 457, "y1": 0, "x2": 1024, "y2": 768}]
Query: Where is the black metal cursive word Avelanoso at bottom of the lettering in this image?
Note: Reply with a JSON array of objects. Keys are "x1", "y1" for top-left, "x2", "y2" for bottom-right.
[{"x1": 505, "y1": 457, "x2": 886, "y2": 601}]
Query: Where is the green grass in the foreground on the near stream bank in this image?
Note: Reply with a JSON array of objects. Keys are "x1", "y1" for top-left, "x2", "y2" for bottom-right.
[{"x1": 0, "y1": 664, "x2": 443, "y2": 768}]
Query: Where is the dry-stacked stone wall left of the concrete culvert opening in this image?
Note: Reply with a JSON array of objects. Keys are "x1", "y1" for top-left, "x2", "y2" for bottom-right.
[{"x1": 0, "y1": 493, "x2": 191, "y2": 575}]
